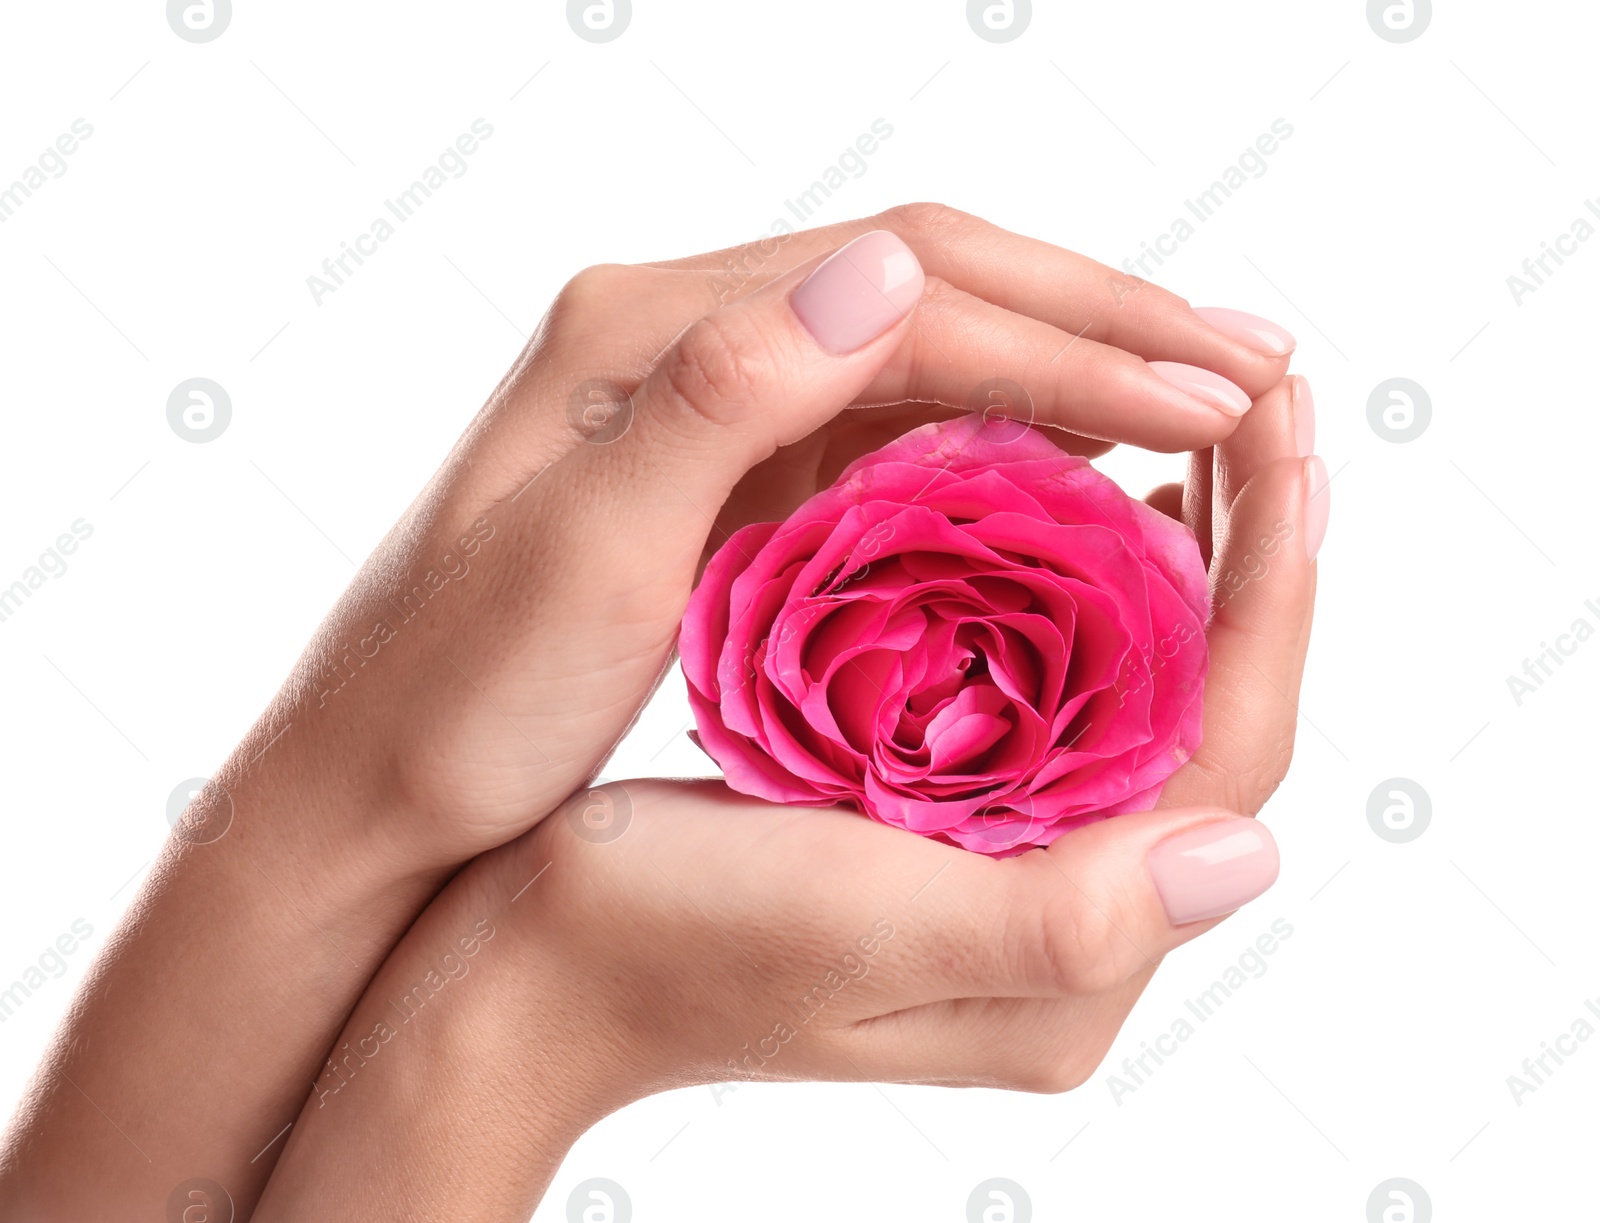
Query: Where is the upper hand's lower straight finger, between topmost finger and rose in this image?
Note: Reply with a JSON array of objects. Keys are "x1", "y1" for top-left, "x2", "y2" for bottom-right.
[{"x1": 861, "y1": 280, "x2": 1250, "y2": 451}]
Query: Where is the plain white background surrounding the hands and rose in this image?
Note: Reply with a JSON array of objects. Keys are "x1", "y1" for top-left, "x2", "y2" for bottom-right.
[{"x1": 0, "y1": 0, "x2": 1600, "y2": 1223}]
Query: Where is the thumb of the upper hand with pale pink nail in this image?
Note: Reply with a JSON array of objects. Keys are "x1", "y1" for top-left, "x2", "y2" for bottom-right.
[{"x1": 597, "y1": 231, "x2": 923, "y2": 515}]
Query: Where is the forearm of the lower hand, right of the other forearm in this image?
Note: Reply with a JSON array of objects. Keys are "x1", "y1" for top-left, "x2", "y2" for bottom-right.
[{"x1": 254, "y1": 847, "x2": 620, "y2": 1223}]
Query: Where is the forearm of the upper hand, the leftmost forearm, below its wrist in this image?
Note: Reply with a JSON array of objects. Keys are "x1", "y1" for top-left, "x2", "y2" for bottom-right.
[{"x1": 0, "y1": 749, "x2": 443, "y2": 1220}]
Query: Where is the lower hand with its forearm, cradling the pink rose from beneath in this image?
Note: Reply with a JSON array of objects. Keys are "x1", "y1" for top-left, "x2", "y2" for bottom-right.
[{"x1": 256, "y1": 368, "x2": 1328, "y2": 1221}]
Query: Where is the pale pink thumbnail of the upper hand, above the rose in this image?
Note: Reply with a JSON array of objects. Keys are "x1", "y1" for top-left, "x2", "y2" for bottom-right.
[{"x1": 789, "y1": 229, "x2": 923, "y2": 355}]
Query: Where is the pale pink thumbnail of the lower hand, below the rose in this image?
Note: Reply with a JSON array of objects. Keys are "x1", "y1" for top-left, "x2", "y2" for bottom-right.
[{"x1": 1149, "y1": 816, "x2": 1278, "y2": 925}]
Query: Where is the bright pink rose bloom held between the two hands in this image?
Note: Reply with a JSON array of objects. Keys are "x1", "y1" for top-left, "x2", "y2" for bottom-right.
[{"x1": 678, "y1": 416, "x2": 1210, "y2": 856}]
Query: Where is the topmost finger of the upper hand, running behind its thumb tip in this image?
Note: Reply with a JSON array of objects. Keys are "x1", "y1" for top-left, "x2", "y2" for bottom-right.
[{"x1": 649, "y1": 203, "x2": 1294, "y2": 397}]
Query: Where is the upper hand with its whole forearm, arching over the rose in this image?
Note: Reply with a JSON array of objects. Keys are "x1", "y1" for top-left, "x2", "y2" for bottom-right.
[{"x1": 0, "y1": 207, "x2": 1290, "y2": 1218}]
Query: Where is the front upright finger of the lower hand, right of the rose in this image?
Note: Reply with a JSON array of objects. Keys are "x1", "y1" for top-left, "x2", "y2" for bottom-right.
[{"x1": 1162, "y1": 456, "x2": 1328, "y2": 813}]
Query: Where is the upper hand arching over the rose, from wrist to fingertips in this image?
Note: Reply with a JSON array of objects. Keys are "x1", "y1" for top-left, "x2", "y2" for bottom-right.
[{"x1": 246, "y1": 205, "x2": 1291, "y2": 864}]
